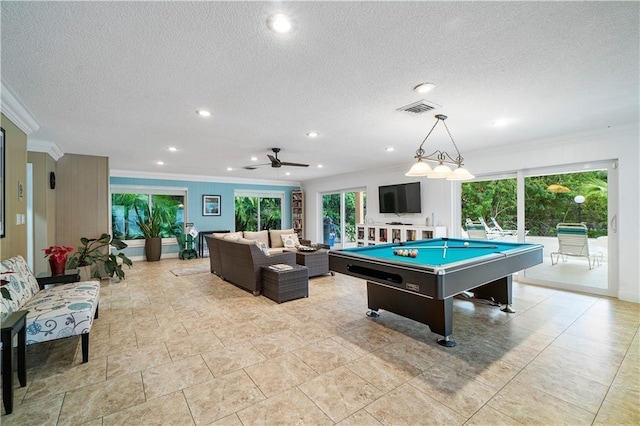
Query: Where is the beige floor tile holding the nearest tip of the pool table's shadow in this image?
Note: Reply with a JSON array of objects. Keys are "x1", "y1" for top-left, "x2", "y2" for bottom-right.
[{"x1": 409, "y1": 365, "x2": 495, "y2": 418}]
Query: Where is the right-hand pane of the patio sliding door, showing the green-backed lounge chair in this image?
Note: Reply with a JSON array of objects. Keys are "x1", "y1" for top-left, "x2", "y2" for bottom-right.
[{"x1": 523, "y1": 163, "x2": 617, "y2": 295}]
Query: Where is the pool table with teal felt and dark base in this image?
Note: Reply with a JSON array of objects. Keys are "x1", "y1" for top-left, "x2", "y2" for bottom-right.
[{"x1": 329, "y1": 238, "x2": 542, "y2": 347}]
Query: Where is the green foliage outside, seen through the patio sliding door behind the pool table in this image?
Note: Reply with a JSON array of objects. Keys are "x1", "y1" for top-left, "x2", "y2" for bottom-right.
[{"x1": 461, "y1": 171, "x2": 608, "y2": 238}]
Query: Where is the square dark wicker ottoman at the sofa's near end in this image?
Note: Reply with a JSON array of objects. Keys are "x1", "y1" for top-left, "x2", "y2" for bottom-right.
[{"x1": 262, "y1": 265, "x2": 309, "y2": 303}]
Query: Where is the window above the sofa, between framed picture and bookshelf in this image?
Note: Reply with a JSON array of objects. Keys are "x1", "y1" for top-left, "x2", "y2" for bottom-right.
[{"x1": 234, "y1": 191, "x2": 284, "y2": 231}]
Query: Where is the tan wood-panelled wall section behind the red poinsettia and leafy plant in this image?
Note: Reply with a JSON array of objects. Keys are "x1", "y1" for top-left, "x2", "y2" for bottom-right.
[{"x1": 56, "y1": 154, "x2": 111, "y2": 248}]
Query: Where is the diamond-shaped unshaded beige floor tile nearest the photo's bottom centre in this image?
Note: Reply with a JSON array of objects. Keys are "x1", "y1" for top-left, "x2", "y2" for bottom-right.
[{"x1": 298, "y1": 367, "x2": 383, "y2": 422}]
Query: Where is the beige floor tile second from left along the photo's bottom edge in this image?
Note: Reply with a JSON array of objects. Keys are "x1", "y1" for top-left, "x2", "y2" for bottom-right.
[{"x1": 58, "y1": 373, "x2": 145, "y2": 425}]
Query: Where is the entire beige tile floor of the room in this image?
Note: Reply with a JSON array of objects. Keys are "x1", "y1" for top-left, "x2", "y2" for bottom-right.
[{"x1": 0, "y1": 259, "x2": 640, "y2": 426}]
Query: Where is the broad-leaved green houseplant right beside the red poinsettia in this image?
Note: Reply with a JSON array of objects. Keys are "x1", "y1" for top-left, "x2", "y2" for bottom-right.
[{"x1": 67, "y1": 234, "x2": 133, "y2": 279}]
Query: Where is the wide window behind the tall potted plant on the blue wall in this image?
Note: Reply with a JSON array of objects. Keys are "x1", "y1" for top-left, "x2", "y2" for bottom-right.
[{"x1": 111, "y1": 187, "x2": 186, "y2": 240}]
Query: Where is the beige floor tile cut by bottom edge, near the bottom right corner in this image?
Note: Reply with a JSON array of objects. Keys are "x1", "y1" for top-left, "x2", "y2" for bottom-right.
[{"x1": 487, "y1": 381, "x2": 595, "y2": 425}]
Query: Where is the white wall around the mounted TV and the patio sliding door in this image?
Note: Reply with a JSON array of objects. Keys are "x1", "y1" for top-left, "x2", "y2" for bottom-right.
[{"x1": 302, "y1": 124, "x2": 640, "y2": 303}]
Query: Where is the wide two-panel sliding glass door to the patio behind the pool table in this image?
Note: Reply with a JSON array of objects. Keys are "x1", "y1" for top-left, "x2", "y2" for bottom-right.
[{"x1": 460, "y1": 161, "x2": 617, "y2": 295}]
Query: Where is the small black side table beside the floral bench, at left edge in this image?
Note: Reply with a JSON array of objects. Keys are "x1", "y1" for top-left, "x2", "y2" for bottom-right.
[{"x1": 2, "y1": 311, "x2": 29, "y2": 414}]
